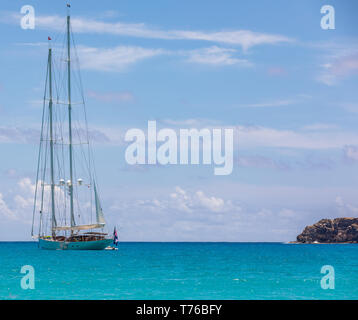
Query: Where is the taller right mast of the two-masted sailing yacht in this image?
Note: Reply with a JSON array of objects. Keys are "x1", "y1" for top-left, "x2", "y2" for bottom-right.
[{"x1": 67, "y1": 9, "x2": 76, "y2": 228}]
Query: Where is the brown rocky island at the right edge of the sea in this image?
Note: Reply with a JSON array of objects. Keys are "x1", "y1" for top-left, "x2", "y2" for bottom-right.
[{"x1": 295, "y1": 218, "x2": 358, "y2": 243}]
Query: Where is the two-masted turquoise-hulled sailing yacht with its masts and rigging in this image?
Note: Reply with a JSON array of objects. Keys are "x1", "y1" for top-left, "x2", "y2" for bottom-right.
[{"x1": 31, "y1": 5, "x2": 113, "y2": 250}]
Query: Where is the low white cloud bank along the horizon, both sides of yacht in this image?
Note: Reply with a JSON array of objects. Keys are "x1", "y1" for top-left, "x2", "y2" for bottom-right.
[{"x1": 0, "y1": 178, "x2": 357, "y2": 241}]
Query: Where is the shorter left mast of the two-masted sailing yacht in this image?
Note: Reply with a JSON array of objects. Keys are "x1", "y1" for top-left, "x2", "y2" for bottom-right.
[{"x1": 48, "y1": 43, "x2": 57, "y2": 237}]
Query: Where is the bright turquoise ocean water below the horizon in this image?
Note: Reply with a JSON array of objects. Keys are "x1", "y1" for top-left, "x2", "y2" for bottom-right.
[{"x1": 0, "y1": 242, "x2": 358, "y2": 299}]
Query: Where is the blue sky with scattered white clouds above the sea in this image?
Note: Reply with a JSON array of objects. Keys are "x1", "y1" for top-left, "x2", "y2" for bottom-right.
[{"x1": 0, "y1": 0, "x2": 358, "y2": 241}]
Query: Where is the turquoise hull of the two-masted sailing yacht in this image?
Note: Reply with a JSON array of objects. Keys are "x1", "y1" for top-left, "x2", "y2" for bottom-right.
[{"x1": 39, "y1": 239, "x2": 113, "y2": 250}]
